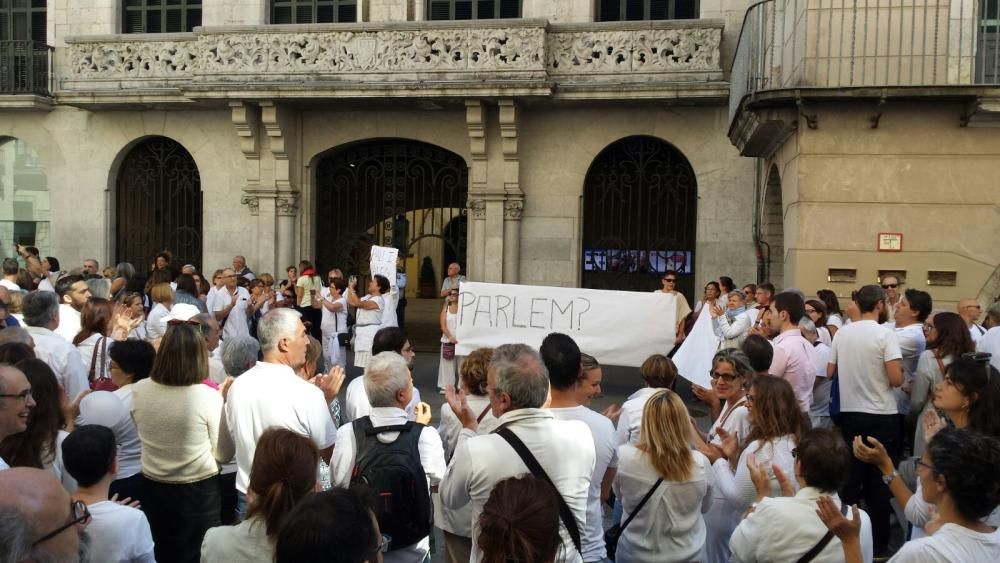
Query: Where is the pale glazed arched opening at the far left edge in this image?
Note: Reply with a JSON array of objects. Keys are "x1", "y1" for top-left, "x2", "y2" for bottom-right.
[{"x1": 0, "y1": 137, "x2": 51, "y2": 258}]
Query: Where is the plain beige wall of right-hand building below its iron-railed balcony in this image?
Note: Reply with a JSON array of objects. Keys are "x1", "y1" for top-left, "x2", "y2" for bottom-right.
[{"x1": 768, "y1": 100, "x2": 1000, "y2": 310}]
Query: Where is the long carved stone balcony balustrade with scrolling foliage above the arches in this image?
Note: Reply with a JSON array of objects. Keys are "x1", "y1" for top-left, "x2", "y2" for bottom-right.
[{"x1": 59, "y1": 19, "x2": 725, "y2": 97}]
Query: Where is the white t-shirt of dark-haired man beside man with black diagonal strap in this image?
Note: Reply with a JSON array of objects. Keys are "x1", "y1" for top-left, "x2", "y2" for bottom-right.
[{"x1": 549, "y1": 405, "x2": 618, "y2": 561}]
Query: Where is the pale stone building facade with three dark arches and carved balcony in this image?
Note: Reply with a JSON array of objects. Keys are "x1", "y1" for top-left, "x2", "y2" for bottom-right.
[{"x1": 0, "y1": 0, "x2": 756, "y2": 304}]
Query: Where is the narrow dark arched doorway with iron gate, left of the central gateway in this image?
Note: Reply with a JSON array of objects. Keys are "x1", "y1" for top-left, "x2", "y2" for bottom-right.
[{"x1": 115, "y1": 137, "x2": 202, "y2": 271}]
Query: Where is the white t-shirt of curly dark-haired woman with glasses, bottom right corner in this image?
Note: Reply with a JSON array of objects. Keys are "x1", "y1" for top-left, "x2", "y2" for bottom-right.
[{"x1": 889, "y1": 524, "x2": 1000, "y2": 563}]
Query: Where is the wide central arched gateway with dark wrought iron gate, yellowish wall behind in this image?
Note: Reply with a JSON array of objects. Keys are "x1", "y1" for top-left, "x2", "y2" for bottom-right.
[{"x1": 316, "y1": 139, "x2": 469, "y2": 278}]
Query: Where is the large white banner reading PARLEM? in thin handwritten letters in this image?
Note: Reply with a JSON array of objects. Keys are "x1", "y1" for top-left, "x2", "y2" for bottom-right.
[{"x1": 456, "y1": 282, "x2": 677, "y2": 367}]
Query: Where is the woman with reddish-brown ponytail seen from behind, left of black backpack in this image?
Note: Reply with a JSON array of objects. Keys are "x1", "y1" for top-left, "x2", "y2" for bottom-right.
[{"x1": 201, "y1": 428, "x2": 319, "y2": 563}]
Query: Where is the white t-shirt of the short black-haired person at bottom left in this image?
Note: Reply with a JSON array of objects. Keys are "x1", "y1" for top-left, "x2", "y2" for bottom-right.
[{"x1": 87, "y1": 500, "x2": 156, "y2": 563}]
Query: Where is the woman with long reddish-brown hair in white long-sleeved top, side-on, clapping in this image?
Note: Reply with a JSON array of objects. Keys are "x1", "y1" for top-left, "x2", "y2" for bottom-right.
[{"x1": 709, "y1": 377, "x2": 805, "y2": 515}]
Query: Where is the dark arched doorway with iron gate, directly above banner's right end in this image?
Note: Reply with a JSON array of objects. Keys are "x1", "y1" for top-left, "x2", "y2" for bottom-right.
[{"x1": 582, "y1": 136, "x2": 698, "y2": 300}]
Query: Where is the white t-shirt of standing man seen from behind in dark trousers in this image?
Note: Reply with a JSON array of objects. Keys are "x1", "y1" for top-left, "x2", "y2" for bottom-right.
[{"x1": 830, "y1": 320, "x2": 903, "y2": 414}]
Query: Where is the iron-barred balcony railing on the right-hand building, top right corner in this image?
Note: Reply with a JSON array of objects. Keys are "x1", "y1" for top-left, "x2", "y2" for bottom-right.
[{"x1": 729, "y1": 0, "x2": 1000, "y2": 122}]
